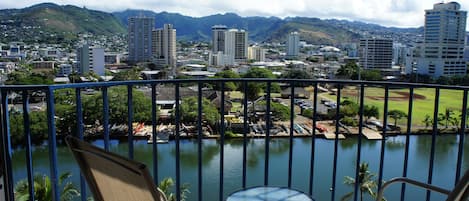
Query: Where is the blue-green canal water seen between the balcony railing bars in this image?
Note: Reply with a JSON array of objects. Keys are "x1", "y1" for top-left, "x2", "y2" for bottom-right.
[{"x1": 9, "y1": 135, "x2": 469, "y2": 200}]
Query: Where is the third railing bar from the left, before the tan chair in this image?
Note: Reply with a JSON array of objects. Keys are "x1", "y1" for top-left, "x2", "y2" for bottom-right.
[{"x1": 46, "y1": 88, "x2": 60, "y2": 200}]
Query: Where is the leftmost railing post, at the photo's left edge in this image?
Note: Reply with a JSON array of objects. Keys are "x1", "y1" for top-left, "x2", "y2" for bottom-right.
[{"x1": 0, "y1": 90, "x2": 14, "y2": 200}]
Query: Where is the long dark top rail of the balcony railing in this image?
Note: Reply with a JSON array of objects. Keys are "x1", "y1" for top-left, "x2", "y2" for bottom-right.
[{"x1": 0, "y1": 78, "x2": 469, "y2": 91}]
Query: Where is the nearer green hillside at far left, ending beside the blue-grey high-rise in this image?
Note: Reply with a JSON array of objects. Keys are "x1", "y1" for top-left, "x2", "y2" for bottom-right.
[{"x1": 0, "y1": 3, "x2": 126, "y2": 42}]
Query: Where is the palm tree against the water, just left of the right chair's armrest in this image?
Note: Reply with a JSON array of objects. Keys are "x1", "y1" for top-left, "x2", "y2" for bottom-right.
[{"x1": 340, "y1": 162, "x2": 377, "y2": 201}]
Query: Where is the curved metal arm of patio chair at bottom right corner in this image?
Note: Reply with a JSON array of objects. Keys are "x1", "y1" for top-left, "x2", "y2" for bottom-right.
[{"x1": 376, "y1": 169, "x2": 469, "y2": 201}]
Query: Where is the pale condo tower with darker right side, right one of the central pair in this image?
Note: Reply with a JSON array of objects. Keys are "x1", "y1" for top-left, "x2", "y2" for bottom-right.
[{"x1": 225, "y1": 29, "x2": 248, "y2": 64}]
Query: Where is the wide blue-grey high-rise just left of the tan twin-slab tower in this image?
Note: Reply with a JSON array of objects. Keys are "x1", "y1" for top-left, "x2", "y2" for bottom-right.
[{"x1": 128, "y1": 17, "x2": 155, "y2": 62}]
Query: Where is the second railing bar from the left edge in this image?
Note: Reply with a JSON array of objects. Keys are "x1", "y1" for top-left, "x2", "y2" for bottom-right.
[{"x1": 23, "y1": 90, "x2": 35, "y2": 200}]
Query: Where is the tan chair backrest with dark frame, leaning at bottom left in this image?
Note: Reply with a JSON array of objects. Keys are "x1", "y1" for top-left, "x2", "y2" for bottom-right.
[{"x1": 65, "y1": 136, "x2": 166, "y2": 201}]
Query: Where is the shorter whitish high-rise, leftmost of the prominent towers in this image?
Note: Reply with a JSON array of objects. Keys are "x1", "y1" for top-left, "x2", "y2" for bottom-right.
[{"x1": 77, "y1": 44, "x2": 104, "y2": 76}]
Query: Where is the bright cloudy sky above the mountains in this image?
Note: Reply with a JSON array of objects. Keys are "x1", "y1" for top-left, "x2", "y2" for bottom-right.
[{"x1": 0, "y1": 0, "x2": 469, "y2": 30}]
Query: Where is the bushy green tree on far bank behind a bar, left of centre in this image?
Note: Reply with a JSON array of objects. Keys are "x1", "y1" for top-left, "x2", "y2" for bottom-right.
[{"x1": 180, "y1": 96, "x2": 220, "y2": 126}]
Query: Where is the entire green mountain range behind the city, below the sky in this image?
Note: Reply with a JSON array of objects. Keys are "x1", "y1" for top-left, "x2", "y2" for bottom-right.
[{"x1": 0, "y1": 3, "x2": 423, "y2": 44}]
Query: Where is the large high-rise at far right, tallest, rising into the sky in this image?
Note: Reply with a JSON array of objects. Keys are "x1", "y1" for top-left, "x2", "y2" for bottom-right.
[{"x1": 406, "y1": 2, "x2": 467, "y2": 77}]
